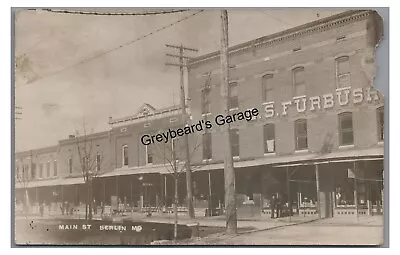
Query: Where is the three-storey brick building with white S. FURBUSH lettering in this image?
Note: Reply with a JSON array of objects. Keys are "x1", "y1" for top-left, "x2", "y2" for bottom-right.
[{"x1": 188, "y1": 11, "x2": 384, "y2": 218}]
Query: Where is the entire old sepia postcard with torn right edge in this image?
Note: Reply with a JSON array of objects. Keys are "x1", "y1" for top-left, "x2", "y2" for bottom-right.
[{"x1": 11, "y1": 8, "x2": 389, "y2": 247}]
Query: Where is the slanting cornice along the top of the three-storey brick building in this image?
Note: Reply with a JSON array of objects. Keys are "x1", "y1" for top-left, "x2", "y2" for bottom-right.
[{"x1": 187, "y1": 10, "x2": 375, "y2": 68}]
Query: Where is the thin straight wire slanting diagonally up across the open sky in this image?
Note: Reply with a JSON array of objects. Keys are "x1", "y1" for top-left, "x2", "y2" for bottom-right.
[{"x1": 15, "y1": 10, "x2": 203, "y2": 87}]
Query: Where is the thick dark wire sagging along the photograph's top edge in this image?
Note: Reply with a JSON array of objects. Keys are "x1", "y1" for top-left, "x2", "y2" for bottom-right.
[{"x1": 29, "y1": 9, "x2": 189, "y2": 16}]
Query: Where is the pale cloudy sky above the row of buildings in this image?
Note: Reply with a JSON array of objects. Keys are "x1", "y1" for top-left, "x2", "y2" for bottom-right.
[{"x1": 15, "y1": 8, "x2": 343, "y2": 151}]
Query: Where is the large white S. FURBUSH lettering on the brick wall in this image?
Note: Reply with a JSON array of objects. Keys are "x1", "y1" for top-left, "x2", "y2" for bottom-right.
[{"x1": 264, "y1": 87, "x2": 379, "y2": 118}]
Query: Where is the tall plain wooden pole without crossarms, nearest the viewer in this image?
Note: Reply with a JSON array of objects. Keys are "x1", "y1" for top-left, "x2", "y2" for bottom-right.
[{"x1": 221, "y1": 10, "x2": 237, "y2": 234}]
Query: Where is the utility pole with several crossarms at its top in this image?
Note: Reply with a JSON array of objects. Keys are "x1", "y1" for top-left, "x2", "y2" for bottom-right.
[{"x1": 166, "y1": 44, "x2": 198, "y2": 218}]
